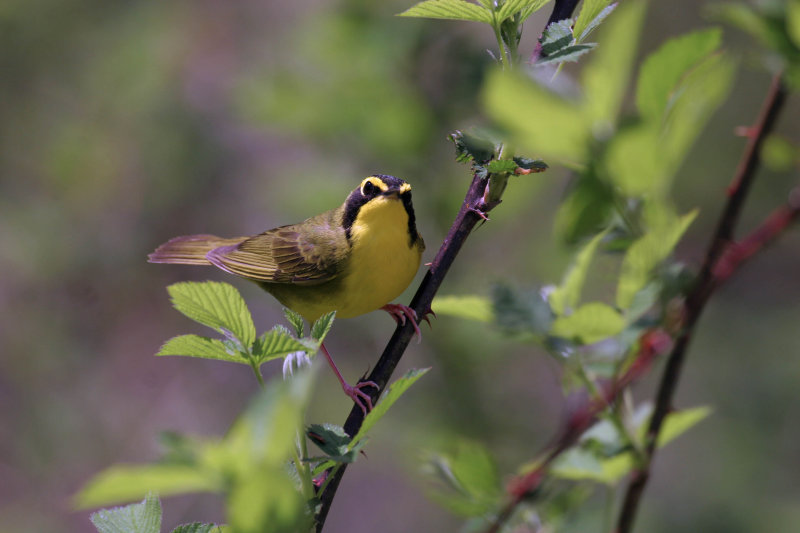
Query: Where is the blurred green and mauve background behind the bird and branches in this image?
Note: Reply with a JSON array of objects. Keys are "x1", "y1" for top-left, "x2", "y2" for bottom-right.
[{"x1": 0, "y1": 0, "x2": 800, "y2": 533}]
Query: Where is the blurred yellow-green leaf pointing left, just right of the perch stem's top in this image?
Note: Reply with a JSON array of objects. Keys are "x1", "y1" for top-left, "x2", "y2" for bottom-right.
[{"x1": 483, "y1": 70, "x2": 589, "y2": 162}]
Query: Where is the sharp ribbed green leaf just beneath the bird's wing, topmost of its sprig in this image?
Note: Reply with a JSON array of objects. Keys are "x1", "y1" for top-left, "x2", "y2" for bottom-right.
[{"x1": 167, "y1": 281, "x2": 256, "y2": 348}]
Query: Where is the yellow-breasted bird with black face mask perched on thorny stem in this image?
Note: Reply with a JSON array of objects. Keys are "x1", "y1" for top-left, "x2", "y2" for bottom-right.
[{"x1": 148, "y1": 174, "x2": 425, "y2": 414}]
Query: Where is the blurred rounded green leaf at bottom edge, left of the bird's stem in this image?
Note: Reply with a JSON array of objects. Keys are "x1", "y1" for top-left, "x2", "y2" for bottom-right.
[{"x1": 227, "y1": 464, "x2": 312, "y2": 533}]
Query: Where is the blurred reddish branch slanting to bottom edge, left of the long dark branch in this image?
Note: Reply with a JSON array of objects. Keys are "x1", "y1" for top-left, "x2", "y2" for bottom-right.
[{"x1": 487, "y1": 329, "x2": 672, "y2": 533}]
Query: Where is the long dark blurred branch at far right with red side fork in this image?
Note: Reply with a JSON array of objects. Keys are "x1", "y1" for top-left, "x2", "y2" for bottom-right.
[{"x1": 616, "y1": 74, "x2": 798, "y2": 533}]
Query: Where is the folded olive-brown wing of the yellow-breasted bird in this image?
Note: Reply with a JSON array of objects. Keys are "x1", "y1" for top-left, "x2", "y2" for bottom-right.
[{"x1": 206, "y1": 209, "x2": 350, "y2": 285}]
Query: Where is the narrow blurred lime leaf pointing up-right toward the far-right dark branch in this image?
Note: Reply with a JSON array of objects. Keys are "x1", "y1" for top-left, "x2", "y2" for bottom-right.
[{"x1": 616, "y1": 211, "x2": 697, "y2": 309}]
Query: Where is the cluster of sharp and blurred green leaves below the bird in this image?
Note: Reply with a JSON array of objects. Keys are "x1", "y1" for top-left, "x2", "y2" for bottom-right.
[{"x1": 75, "y1": 282, "x2": 427, "y2": 533}]
